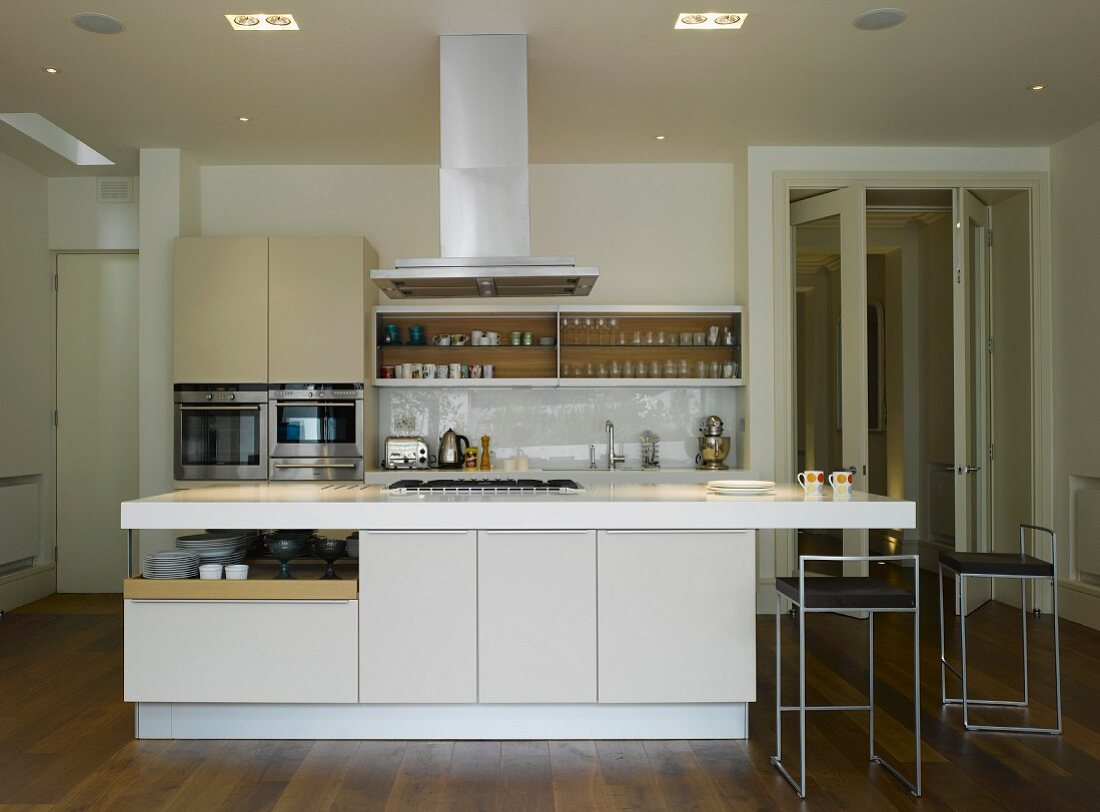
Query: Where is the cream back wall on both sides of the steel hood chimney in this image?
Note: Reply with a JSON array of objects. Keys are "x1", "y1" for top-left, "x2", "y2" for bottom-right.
[{"x1": 202, "y1": 164, "x2": 744, "y2": 304}]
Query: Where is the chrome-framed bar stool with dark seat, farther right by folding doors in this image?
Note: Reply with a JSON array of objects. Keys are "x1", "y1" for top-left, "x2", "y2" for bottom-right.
[{"x1": 939, "y1": 524, "x2": 1062, "y2": 735}]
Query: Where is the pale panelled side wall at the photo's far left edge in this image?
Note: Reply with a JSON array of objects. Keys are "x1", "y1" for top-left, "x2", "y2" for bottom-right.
[{"x1": 0, "y1": 153, "x2": 54, "y2": 608}]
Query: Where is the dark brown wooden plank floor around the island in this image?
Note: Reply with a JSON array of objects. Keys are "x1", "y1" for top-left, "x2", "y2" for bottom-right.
[{"x1": 0, "y1": 568, "x2": 1100, "y2": 812}]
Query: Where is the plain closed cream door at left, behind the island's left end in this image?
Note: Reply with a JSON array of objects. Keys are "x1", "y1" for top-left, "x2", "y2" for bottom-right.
[{"x1": 56, "y1": 254, "x2": 138, "y2": 593}]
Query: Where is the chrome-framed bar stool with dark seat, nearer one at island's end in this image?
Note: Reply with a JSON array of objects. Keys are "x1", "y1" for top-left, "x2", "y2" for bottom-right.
[{"x1": 771, "y1": 555, "x2": 921, "y2": 798}]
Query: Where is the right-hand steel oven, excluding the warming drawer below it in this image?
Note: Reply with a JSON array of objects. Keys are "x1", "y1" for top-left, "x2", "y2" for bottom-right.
[{"x1": 268, "y1": 383, "x2": 364, "y2": 460}]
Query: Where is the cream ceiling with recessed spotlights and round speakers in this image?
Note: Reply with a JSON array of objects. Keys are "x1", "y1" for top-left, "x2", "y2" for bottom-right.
[{"x1": 0, "y1": 0, "x2": 1100, "y2": 175}]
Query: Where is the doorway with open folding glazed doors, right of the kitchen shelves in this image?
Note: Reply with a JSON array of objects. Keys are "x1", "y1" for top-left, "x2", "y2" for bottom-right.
[{"x1": 790, "y1": 185, "x2": 1032, "y2": 611}]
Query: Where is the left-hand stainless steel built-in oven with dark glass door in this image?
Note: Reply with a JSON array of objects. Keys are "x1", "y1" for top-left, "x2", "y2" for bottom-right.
[{"x1": 173, "y1": 384, "x2": 267, "y2": 480}]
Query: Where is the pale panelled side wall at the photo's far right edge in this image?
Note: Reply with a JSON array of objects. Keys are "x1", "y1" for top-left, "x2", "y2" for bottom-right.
[{"x1": 1051, "y1": 123, "x2": 1100, "y2": 627}]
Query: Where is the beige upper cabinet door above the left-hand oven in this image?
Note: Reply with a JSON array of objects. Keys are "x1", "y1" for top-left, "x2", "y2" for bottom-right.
[{"x1": 172, "y1": 237, "x2": 267, "y2": 383}]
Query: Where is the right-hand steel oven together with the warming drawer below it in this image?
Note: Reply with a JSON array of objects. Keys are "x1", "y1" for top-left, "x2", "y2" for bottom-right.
[{"x1": 267, "y1": 383, "x2": 364, "y2": 481}]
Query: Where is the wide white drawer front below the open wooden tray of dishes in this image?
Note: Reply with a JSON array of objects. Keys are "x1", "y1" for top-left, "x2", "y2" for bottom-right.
[{"x1": 123, "y1": 601, "x2": 359, "y2": 703}]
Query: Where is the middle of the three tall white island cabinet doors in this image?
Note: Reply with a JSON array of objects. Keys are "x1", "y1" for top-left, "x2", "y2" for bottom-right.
[{"x1": 477, "y1": 530, "x2": 596, "y2": 703}]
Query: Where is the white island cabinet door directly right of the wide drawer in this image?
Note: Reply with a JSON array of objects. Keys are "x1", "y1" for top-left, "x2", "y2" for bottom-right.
[{"x1": 359, "y1": 530, "x2": 477, "y2": 702}]
